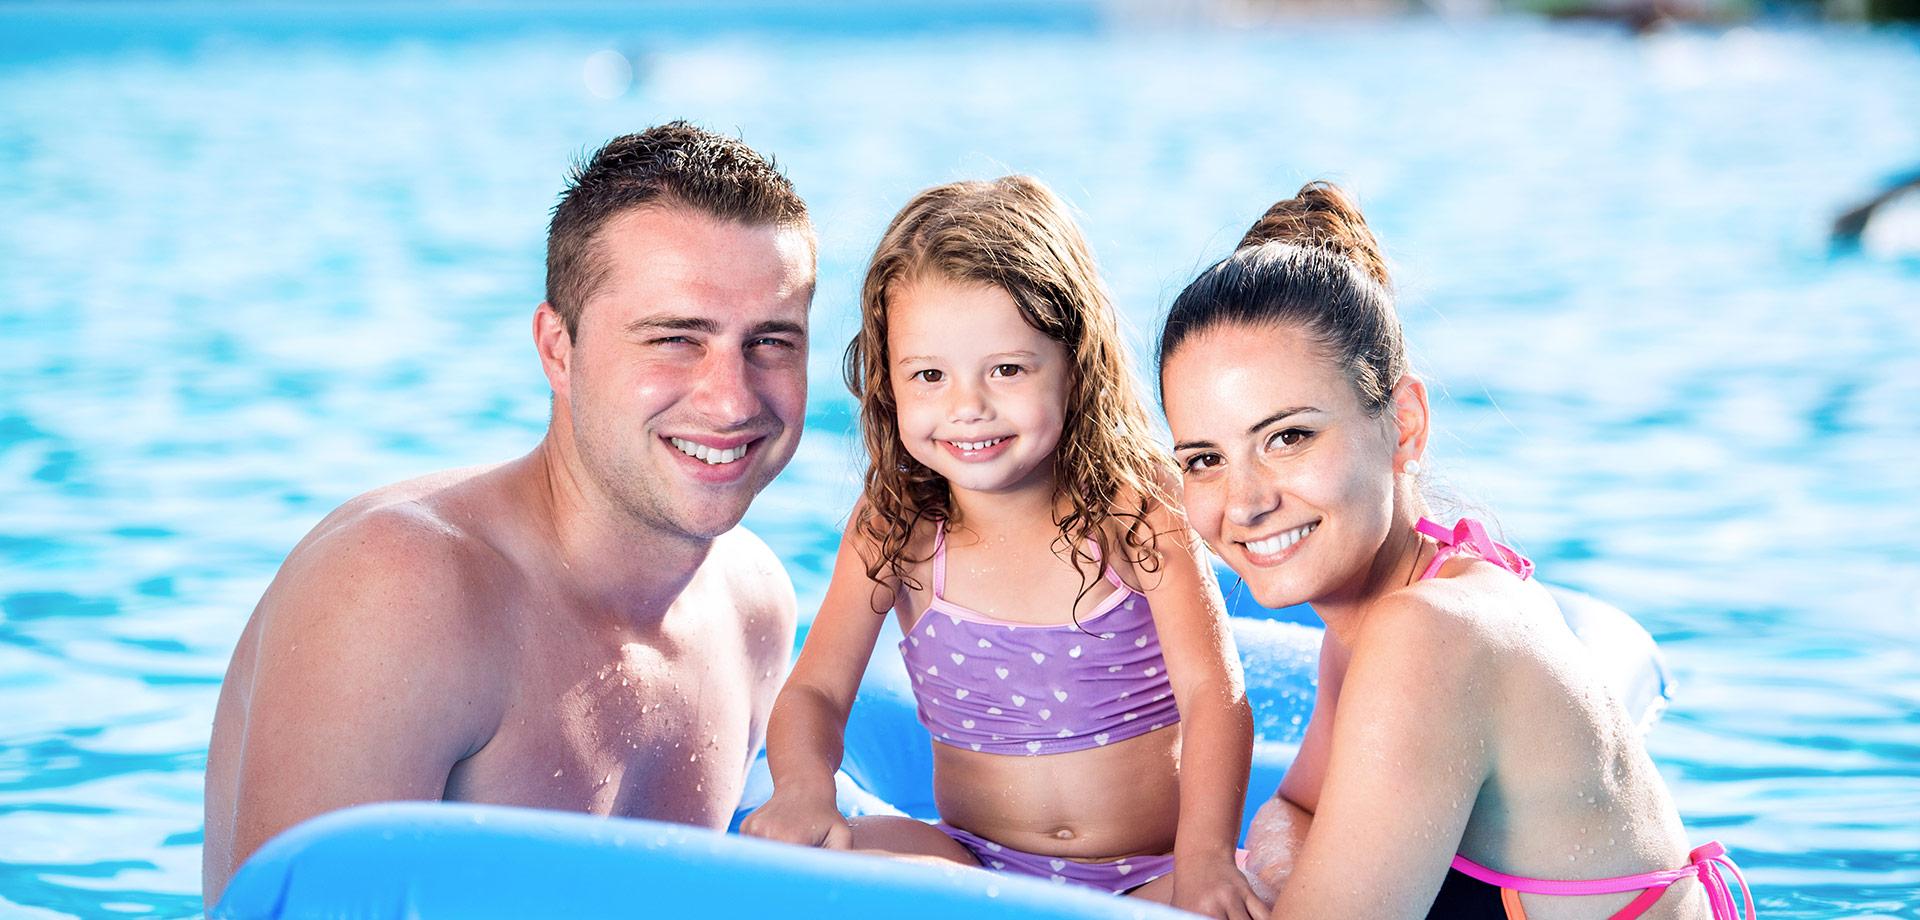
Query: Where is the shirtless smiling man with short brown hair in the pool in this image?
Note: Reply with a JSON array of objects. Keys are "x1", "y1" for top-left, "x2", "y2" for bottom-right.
[{"x1": 204, "y1": 123, "x2": 814, "y2": 905}]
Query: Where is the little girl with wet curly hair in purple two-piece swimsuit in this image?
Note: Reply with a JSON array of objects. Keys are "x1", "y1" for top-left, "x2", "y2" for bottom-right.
[{"x1": 741, "y1": 177, "x2": 1263, "y2": 918}]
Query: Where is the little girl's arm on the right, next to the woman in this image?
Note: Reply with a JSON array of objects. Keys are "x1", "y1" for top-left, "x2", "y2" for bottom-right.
[{"x1": 1137, "y1": 507, "x2": 1265, "y2": 918}]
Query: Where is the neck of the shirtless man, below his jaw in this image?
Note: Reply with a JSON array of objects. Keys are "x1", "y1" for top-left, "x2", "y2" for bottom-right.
[{"x1": 522, "y1": 430, "x2": 712, "y2": 626}]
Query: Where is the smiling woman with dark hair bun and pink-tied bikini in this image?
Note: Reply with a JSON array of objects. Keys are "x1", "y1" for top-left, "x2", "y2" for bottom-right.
[{"x1": 1160, "y1": 184, "x2": 1751, "y2": 920}]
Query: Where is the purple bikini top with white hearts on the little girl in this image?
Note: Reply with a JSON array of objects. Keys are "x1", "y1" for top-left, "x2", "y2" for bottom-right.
[{"x1": 900, "y1": 526, "x2": 1181, "y2": 755}]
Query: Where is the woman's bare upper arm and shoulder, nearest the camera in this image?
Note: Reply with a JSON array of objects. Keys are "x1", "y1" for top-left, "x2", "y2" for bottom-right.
[{"x1": 1273, "y1": 597, "x2": 1498, "y2": 920}]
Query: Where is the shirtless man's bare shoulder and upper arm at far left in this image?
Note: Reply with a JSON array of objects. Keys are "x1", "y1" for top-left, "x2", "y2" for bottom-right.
[{"x1": 204, "y1": 511, "x2": 501, "y2": 905}]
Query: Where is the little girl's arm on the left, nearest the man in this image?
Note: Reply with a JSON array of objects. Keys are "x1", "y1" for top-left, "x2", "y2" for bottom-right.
[{"x1": 739, "y1": 505, "x2": 893, "y2": 849}]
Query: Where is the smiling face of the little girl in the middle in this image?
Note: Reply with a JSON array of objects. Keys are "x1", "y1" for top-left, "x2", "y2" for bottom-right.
[{"x1": 887, "y1": 277, "x2": 1071, "y2": 492}]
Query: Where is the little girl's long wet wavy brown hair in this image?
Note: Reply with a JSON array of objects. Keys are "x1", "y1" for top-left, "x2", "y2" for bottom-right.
[{"x1": 845, "y1": 175, "x2": 1173, "y2": 613}]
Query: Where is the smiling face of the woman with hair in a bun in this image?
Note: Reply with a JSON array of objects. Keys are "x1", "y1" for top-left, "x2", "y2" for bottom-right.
[{"x1": 1162, "y1": 325, "x2": 1425, "y2": 607}]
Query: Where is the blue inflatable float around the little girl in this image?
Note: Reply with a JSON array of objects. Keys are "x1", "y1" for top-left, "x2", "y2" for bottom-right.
[{"x1": 213, "y1": 590, "x2": 1670, "y2": 920}]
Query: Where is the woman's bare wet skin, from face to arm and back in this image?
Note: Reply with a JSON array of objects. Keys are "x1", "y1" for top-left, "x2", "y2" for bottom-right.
[{"x1": 1162, "y1": 325, "x2": 1707, "y2": 920}]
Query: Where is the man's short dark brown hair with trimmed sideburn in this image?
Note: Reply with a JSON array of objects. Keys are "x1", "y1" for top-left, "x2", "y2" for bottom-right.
[{"x1": 547, "y1": 121, "x2": 812, "y2": 336}]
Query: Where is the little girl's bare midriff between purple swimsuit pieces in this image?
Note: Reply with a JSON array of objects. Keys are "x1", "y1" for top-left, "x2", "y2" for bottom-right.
[{"x1": 933, "y1": 724, "x2": 1181, "y2": 862}]
